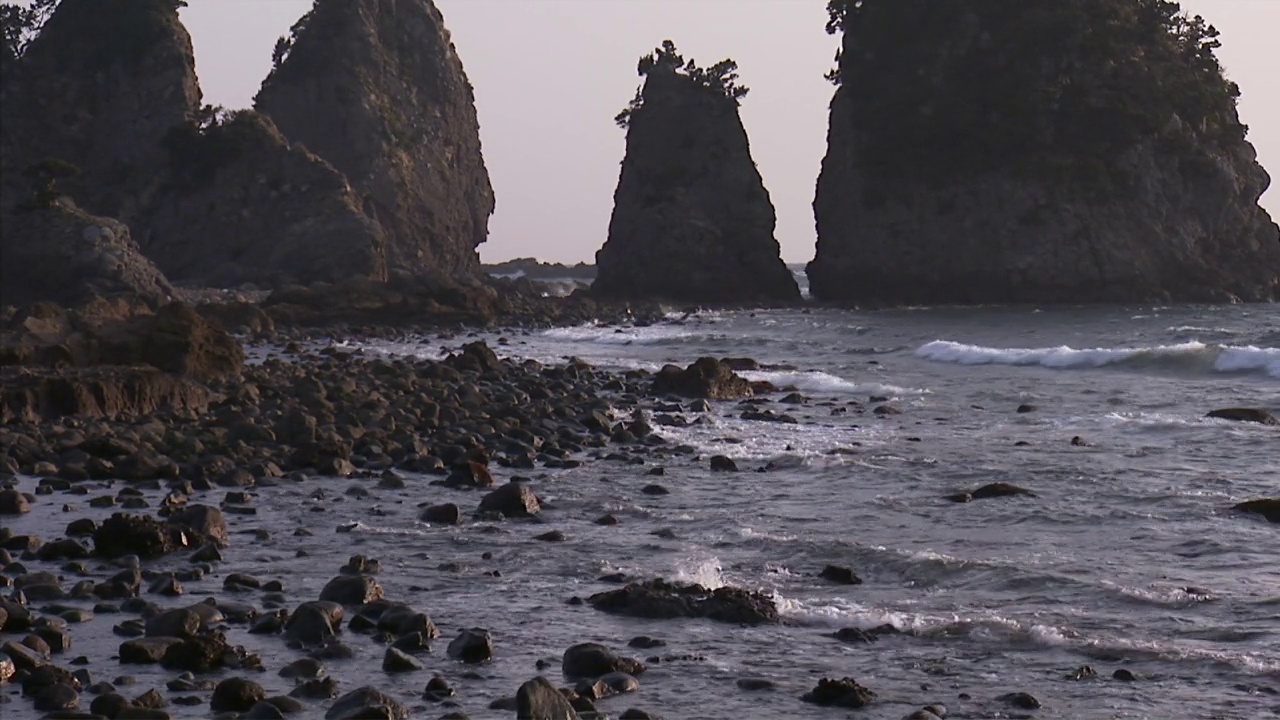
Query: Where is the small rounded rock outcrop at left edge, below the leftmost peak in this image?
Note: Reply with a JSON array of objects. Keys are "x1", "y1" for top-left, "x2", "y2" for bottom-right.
[{"x1": 0, "y1": 200, "x2": 173, "y2": 306}]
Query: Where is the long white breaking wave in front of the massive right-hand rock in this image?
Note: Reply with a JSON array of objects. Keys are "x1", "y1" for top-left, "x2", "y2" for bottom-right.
[{"x1": 915, "y1": 340, "x2": 1280, "y2": 378}]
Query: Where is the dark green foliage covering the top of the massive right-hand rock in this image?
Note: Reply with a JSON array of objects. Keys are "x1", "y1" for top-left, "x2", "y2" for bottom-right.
[{"x1": 827, "y1": 0, "x2": 1244, "y2": 182}]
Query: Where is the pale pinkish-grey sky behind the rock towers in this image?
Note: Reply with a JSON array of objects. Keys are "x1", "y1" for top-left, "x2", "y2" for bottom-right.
[{"x1": 182, "y1": 0, "x2": 1280, "y2": 263}]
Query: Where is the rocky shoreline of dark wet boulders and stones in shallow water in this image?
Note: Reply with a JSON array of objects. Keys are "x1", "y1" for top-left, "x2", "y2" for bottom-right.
[{"x1": 0, "y1": 307, "x2": 1274, "y2": 720}]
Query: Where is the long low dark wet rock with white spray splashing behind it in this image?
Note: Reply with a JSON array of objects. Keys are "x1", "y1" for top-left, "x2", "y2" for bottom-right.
[{"x1": 586, "y1": 579, "x2": 778, "y2": 625}]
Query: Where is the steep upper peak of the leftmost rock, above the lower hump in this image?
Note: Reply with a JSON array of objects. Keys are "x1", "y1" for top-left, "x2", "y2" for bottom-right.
[{"x1": 0, "y1": 0, "x2": 201, "y2": 223}]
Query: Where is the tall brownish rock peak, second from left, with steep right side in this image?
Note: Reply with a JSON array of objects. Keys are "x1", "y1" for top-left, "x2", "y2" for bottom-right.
[{"x1": 256, "y1": 0, "x2": 494, "y2": 274}]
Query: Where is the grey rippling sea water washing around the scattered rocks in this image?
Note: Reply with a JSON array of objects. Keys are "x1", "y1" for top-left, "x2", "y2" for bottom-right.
[{"x1": 5, "y1": 299, "x2": 1280, "y2": 720}]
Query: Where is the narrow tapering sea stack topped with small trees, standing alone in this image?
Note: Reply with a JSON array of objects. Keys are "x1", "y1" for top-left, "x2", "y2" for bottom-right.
[{"x1": 591, "y1": 41, "x2": 800, "y2": 304}]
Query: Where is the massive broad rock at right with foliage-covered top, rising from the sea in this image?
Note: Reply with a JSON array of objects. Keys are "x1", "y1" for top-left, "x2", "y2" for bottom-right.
[{"x1": 808, "y1": 0, "x2": 1280, "y2": 304}]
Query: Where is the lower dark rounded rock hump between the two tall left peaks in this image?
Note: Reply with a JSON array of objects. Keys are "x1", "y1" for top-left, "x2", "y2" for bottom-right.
[{"x1": 140, "y1": 110, "x2": 387, "y2": 287}]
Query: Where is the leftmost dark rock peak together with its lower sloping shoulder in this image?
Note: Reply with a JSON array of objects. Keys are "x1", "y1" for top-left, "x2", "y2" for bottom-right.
[{"x1": 0, "y1": 0, "x2": 387, "y2": 284}]
